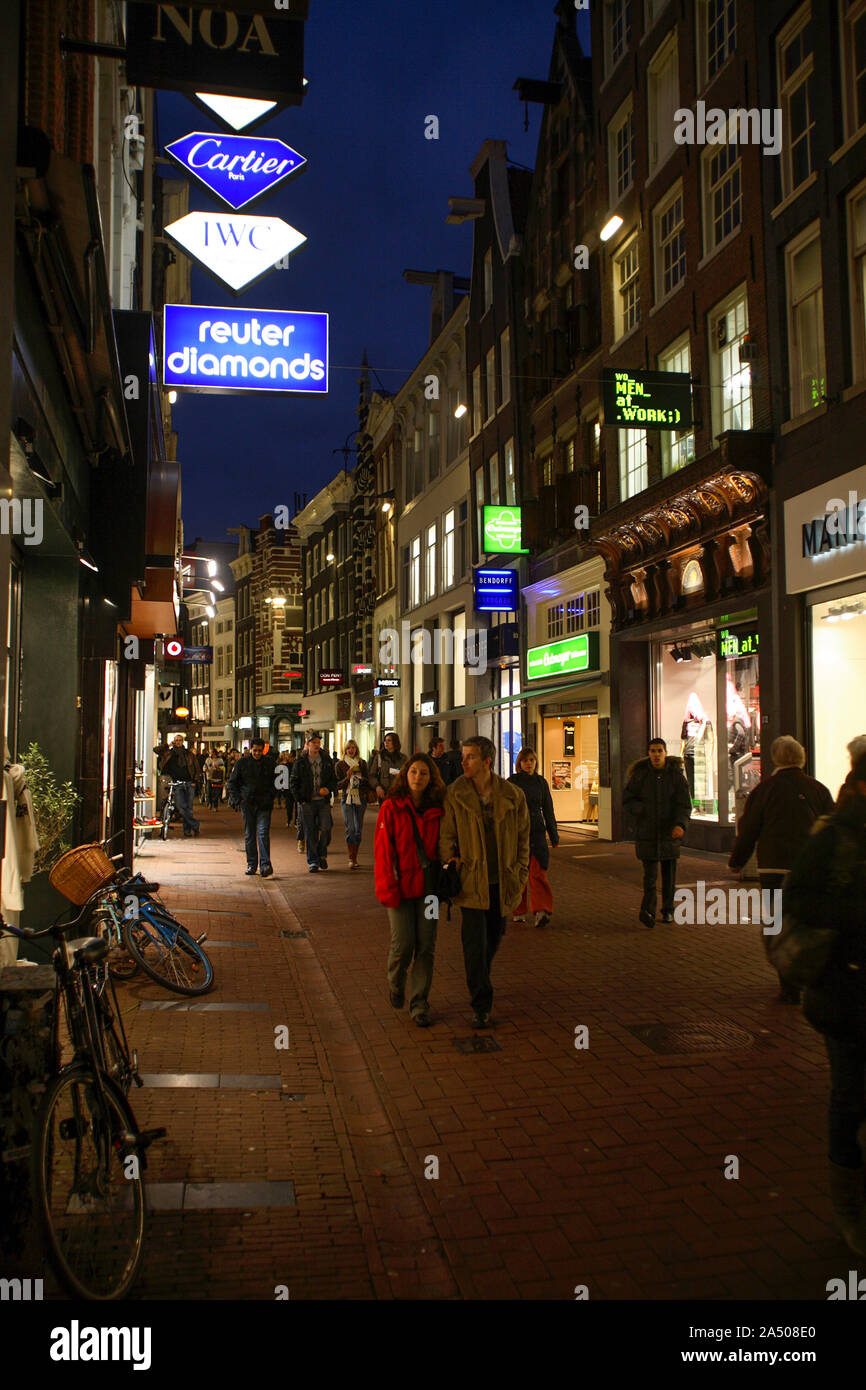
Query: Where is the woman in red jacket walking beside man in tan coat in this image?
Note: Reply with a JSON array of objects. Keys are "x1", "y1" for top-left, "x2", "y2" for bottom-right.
[{"x1": 373, "y1": 753, "x2": 445, "y2": 1029}]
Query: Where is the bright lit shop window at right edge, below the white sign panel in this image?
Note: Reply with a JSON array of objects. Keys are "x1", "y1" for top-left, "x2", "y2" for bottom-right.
[{"x1": 808, "y1": 592, "x2": 866, "y2": 796}]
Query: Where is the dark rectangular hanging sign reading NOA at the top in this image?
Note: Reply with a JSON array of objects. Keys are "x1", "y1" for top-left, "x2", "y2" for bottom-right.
[{"x1": 126, "y1": 3, "x2": 304, "y2": 106}]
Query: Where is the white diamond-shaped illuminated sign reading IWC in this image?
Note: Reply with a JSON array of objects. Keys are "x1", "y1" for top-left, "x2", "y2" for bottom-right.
[{"x1": 165, "y1": 213, "x2": 307, "y2": 291}]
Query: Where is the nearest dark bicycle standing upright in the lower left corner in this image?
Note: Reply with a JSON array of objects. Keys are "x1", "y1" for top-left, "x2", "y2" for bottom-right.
[{"x1": 0, "y1": 904, "x2": 165, "y2": 1301}]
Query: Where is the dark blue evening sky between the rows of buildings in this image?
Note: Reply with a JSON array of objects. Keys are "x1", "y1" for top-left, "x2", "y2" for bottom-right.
[{"x1": 158, "y1": 0, "x2": 589, "y2": 541}]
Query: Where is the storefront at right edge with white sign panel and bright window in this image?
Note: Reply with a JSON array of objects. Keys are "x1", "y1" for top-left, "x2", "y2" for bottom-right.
[{"x1": 784, "y1": 467, "x2": 866, "y2": 795}]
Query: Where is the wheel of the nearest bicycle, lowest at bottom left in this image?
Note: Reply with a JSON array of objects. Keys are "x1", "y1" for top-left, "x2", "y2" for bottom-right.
[{"x1": 32, "y1": 1063, "x2": 145, "y2": 1301}]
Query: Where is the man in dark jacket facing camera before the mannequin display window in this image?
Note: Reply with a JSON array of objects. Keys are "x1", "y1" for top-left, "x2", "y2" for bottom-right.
[{"x1": 623, "y1": 738, "x2": 692, "y2": 927}]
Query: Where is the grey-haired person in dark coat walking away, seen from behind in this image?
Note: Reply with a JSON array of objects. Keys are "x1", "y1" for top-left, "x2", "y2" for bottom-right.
[{"x1": 728, "y1": 734, "x2": 834, "y2": 1004}]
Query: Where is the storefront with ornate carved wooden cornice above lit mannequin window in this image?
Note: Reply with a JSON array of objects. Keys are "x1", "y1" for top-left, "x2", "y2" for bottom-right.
[{"x1": 592, "y1": 470, "x2": 773, "y2": 851}]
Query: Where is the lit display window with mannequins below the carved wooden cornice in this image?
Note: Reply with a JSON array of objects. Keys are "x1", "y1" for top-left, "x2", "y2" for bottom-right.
[{"x1": 652, "y1": 621, "x2": 760, "y2": 824}]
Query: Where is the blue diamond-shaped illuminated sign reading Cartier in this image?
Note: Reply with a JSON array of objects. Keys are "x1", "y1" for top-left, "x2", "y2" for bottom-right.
[{"x1": 165, "y1": 131, "x2": 307, "y2": 211}]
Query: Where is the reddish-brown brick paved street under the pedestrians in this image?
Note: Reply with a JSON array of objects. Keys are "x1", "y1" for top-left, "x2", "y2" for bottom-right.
[{"x1": 111, "y1": 810, "x2": 852, "y2": 1300}]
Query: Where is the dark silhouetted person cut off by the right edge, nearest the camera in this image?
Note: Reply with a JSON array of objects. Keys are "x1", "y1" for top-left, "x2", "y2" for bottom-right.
[{"x1": 783, "y1": 755, "x2": 866, "y2": 1255}]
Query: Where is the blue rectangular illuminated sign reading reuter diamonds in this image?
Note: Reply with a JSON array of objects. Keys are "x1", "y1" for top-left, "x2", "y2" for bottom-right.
[{"x1": 163, "y1": 304, "x2": 328, "y2": 395}]
